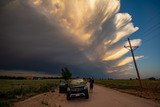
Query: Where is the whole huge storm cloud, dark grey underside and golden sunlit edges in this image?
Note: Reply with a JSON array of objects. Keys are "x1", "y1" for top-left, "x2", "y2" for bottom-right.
[{"x1": 0, "y1": 0, "x2": 142, "y2": 77}]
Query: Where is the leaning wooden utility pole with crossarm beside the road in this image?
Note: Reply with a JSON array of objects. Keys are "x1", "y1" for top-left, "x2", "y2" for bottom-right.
[{"x1": 124, "y1": 38, "x2": 142, "y2": 89}]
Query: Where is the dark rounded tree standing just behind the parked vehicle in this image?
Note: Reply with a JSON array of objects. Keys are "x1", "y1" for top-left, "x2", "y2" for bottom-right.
[{"x1": 61, "y1": 67, "x2": 72, "y2": 80}]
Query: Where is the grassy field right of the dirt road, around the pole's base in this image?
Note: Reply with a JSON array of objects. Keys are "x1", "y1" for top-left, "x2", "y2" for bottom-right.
[{"x1": 95, "y1": 80, "x2": 160, "y2": 103}]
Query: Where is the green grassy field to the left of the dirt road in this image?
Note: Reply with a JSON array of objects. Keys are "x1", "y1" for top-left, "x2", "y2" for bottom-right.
[{"x1": 0, "y1": 79, "x2": 59, "y2": 107}]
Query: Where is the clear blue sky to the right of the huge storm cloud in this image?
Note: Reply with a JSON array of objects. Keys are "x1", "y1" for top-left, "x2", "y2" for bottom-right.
[{"x1": 120, "y1": 0, "x2": 160, "y2": 78}]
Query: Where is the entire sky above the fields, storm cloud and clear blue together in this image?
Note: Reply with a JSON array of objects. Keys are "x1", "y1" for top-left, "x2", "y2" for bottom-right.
[{"x1": 0, "y1": 0, "x2": 160, "y2": 78}]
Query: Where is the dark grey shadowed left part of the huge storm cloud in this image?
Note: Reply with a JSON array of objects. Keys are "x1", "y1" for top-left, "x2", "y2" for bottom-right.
[{"x1": 0, "y1": 0, "x2": 105, "y2": 75}]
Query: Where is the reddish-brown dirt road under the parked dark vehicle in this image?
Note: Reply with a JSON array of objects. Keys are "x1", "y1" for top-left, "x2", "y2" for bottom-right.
[{"x1": 14, "y1": 85, "x2": 160, "y2": 107}]
